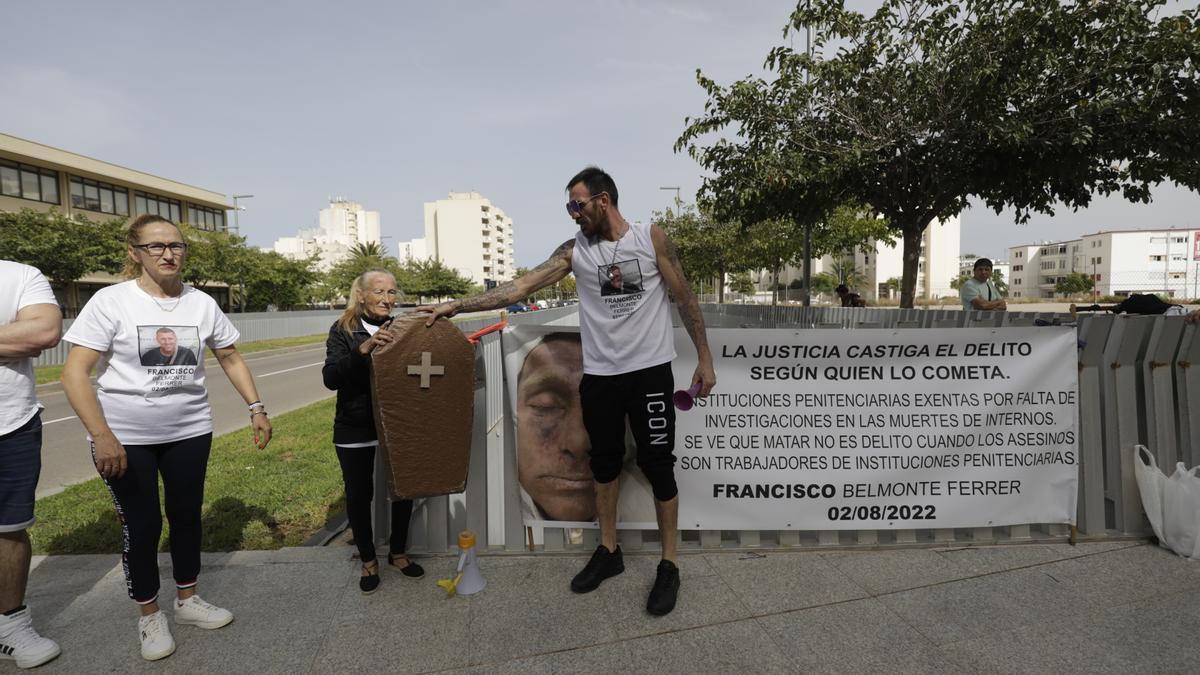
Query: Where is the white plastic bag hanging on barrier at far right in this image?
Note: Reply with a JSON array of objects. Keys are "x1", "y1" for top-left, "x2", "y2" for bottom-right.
[{"x1": 1133, "y1": 446, "x2": 1200, "y2": 558}]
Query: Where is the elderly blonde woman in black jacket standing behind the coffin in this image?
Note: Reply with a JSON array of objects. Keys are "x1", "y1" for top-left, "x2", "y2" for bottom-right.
[{"x1": 320, "y1": 269, "x2": 425, "y2": 593}]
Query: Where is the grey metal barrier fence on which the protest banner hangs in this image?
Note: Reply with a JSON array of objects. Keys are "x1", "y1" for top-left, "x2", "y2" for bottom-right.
[{"x1": 376, "y1": 305, "x2": 1200, "y2": 552}]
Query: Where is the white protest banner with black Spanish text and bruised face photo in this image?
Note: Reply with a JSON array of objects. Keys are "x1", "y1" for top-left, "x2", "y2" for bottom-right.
[{"x1": 503, "y1": 325, "x2": 1079, "y2": 530}]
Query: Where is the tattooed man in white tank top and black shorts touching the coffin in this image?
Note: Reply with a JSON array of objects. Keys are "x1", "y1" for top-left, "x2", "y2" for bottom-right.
[{"x1": 418, "y1": 167, "x2": 716, "y2": 616}]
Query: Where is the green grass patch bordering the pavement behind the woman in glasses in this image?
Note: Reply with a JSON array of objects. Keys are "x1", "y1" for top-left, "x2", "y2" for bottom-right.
[{"x1": 29, "y1": 398, "x2": 346, "y2": 555}]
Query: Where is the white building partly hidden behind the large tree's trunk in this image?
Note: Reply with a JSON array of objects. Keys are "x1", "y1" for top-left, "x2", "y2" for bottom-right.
[{"x1": 751, "y1": 216, "x2": 973, "y2": 303}]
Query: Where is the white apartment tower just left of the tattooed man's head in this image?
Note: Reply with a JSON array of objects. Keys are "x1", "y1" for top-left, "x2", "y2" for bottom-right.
[{"x1": 397, "y1": 192, "x2": 516, "y2": 286}]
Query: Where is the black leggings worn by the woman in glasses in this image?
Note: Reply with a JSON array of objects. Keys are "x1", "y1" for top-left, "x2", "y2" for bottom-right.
[{"x1": 91, "y1": 434, "x2": 212, "y2": 604}]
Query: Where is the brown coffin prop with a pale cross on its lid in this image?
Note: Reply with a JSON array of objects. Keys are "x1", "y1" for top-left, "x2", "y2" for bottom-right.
[{"x1": 371, "y1": 315, "x2": 475, "y2": 498}]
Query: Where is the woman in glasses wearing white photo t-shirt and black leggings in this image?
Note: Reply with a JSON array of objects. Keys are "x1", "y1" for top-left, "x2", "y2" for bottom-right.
[{"x1": 62, "y1": 215, "x2": 271, "y2": 661}]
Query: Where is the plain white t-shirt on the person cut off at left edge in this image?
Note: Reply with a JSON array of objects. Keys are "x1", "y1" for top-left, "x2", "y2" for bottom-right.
[{"x1": 0, "y1": 261, "x2": 59, "y2": 436}]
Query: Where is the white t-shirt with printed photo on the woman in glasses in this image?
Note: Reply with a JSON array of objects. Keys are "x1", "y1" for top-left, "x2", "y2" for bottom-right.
[{"x1": 62, "y1": 280, "x2": 240, "y2": 446}]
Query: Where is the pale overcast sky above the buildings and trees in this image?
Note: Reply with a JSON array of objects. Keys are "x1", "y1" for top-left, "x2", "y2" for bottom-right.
[{"x1": 0, "y1": 0, "x2": 1200, "y2": 267}]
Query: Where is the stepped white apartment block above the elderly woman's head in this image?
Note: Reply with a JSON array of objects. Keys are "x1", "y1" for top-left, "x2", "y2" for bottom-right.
[{"x1": 272, "y1": 197, "x2": 383, "y2": 271}]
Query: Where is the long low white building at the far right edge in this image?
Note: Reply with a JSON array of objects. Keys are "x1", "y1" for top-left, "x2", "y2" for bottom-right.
[{"x1": 1009, "y1": 229, "x2": 1200, "y2": 298}]
